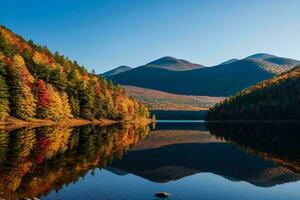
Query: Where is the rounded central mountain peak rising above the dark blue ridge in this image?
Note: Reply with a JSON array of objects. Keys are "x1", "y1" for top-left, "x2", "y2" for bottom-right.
[{"x1": 145, "y1": 56, "x2": 203, "y2": 71}]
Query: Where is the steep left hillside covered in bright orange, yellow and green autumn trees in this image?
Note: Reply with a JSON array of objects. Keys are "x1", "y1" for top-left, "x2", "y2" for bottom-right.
[{"x1": 0, "y1": 26, "x2": 148, "y2": 121}]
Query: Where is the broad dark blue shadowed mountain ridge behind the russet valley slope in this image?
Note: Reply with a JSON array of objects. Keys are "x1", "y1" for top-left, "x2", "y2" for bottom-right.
[{"x1": 109, "y1": 56, "x2": 299, "y2": 96}]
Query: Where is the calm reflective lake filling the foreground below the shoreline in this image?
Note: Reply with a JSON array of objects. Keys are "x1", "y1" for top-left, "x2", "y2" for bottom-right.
[{"x1": 0, "y1": 121, "x2": 300, "y2": 200}]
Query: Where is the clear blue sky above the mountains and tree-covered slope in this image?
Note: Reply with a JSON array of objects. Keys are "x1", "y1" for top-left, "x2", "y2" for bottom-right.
[{"x1": 0, "y1": 0, "x2": 300, "y2": 73}]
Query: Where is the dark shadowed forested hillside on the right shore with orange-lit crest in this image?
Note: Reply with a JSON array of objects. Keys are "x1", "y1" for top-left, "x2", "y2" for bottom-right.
[{"x1": 206, "y1": 66, "x2": 300, "y2": 120}]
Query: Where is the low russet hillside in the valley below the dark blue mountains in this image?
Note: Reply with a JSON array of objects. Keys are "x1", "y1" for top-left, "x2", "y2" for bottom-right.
[{"x1": 122, "y1": 86, "x2": 224, "y2": 110}]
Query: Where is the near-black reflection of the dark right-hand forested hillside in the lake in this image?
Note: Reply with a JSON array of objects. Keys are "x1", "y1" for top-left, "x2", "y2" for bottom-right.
[{"x1": 207, "y1": 123, "x2": 300, "y2": 173}]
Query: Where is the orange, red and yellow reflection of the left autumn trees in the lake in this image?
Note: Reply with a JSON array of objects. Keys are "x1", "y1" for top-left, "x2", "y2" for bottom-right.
[{"x1": 0, "y1": 124, "x2": 149, "y2": 199}]
